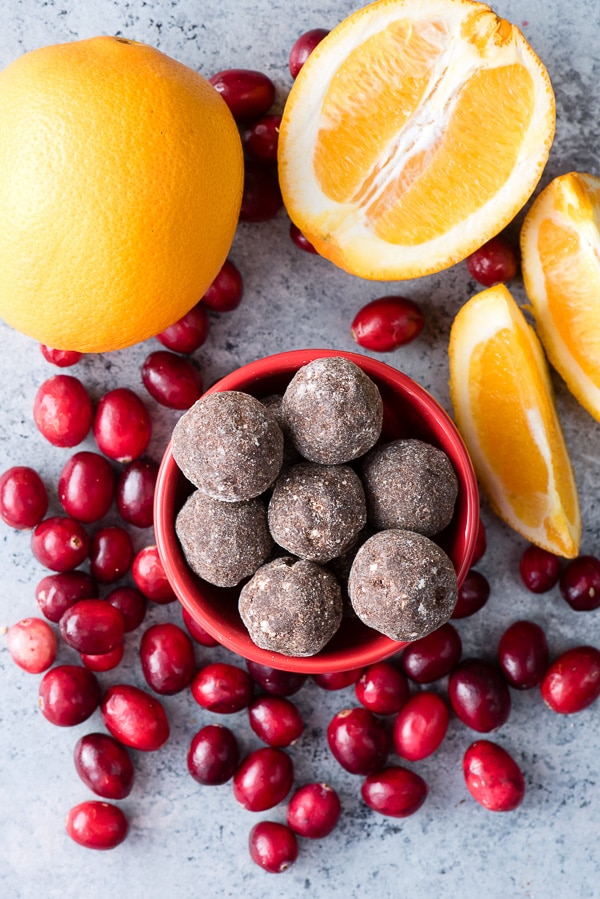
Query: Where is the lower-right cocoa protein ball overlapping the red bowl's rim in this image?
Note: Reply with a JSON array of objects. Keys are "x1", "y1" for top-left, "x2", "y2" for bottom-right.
[{"x1": 348, "y1": 529, "x2": 458, "y2": 641}]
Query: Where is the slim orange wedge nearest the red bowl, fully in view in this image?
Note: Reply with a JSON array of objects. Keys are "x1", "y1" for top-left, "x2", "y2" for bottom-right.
[{"x1": 449, "y1": 284, "x2": 581, "y2": 559}]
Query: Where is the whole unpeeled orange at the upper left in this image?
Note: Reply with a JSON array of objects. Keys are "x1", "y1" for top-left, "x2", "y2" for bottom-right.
[{"x1": 0, "y1": 37, "x2": 243, "y2": 352}]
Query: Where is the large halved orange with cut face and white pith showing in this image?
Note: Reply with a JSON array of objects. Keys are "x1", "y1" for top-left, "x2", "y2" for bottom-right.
[{"x1": 278, "y1": 0, "x2": 555, "y2": 280}]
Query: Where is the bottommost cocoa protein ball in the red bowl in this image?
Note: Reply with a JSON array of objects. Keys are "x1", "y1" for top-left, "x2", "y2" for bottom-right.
[{"x1": 239, "y1": 556, "x2": 342, "y2": 656}]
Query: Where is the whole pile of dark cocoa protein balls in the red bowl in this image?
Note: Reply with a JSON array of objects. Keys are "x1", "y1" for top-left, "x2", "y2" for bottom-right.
[{"x1": 172, "y1": 356, "x2": 458, "y2": 656}]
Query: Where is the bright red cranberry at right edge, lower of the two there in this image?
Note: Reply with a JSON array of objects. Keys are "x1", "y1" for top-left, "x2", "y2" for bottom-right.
[{"x1": 540, "y1": 646, "x2": 600, "y2": 715}]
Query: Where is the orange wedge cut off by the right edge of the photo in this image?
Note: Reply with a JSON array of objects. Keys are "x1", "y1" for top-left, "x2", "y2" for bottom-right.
[{"x1": 521, "y1": 172, "x2": 600, "y2": 421}]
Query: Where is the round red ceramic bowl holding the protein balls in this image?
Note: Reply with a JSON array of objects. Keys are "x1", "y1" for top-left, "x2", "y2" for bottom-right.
[{"x1": 154, "y1": 350, "x2": 479, "y2": 674}]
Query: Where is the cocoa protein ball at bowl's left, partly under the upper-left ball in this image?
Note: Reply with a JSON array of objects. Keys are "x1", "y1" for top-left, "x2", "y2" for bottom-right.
[{"x1": 175, "y1": 490, "x2": 273, "y2": 587}]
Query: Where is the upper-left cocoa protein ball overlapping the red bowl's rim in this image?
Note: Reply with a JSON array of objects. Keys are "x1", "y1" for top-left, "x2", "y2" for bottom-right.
[{"x1": 172, "y1": 390, "x2": 283, "y2": 502}]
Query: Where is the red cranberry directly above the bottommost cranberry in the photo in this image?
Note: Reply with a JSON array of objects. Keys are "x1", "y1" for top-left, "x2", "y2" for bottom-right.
[{"x1": 233, "y1": 746, "x2": 294, "y2": 812}]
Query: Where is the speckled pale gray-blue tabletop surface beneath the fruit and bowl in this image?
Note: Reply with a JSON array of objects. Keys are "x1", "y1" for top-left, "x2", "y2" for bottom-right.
[{"x1": 0, "y1": 0, "x2": 600, "y2": 899}]
